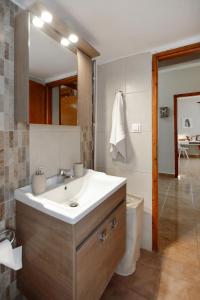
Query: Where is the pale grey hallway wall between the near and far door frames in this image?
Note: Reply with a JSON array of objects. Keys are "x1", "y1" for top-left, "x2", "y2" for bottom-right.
[{"x1": 158, "y1": 66, "x2": 200, "y2": 174}]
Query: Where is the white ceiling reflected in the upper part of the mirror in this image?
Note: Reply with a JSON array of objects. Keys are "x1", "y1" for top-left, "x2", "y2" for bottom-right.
[{"x1": 29, "y1": 25, "x2": 77, "y2": 82}]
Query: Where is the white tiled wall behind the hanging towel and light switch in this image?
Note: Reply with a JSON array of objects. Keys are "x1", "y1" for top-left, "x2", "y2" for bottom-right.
[{"x1": 96, "y1": 53, "x2": 152, "y2": 250}]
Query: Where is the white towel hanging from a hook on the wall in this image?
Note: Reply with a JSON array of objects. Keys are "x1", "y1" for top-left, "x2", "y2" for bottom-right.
[{"x1": 110, "y1": 92, "x2": 126, "y2": 159}]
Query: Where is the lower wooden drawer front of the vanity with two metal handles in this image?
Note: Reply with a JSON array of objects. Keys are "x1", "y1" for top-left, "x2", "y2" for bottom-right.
[{"x1": 76, "y1": 201, "x2": 126, "y2": 300}]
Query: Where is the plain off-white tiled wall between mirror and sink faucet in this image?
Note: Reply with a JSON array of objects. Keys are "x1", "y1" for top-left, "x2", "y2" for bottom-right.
[{"x1": 30, "y1": 125, "x2": 80, "y2": 177}]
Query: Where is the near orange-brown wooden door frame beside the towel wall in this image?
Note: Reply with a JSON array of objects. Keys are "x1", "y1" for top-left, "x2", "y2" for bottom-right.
[{"x1": 152, "y1": 43, "x2": 200, "y2": 251}]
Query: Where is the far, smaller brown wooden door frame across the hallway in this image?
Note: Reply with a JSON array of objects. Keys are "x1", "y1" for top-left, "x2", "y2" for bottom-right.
[{"x1": 174, "y1": 92, "x2": 200, "y2": 178}]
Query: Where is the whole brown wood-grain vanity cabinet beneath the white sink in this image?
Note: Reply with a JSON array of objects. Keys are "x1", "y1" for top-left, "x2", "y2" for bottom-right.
[{"x1": 16, "y1": 185, "x2": 126, "y2": 300}]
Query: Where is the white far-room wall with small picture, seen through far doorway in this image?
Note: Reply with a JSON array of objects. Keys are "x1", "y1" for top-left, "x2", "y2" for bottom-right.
[{"x1": 178, "y1": 96, "x2": 200, "y2": 136}]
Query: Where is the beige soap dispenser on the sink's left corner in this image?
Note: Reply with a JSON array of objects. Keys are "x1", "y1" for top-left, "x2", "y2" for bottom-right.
[{"x1": 32, "y1": 168, "x2": 46, "y2": 195}]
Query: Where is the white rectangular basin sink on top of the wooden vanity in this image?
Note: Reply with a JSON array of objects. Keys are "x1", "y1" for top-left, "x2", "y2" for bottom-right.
[{"x1": 15, "y1": 170, "x2": 126, "y2": 224}]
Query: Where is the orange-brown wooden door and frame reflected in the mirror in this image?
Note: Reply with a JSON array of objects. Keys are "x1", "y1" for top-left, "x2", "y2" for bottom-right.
[{"x1": 29, "y1": 76, "x2": 78, "y2": 126}]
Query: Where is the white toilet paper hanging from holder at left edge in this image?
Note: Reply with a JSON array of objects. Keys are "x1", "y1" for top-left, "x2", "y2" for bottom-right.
[{"x1": 0, "y1": 240, "x2": 22, "y2": 271}]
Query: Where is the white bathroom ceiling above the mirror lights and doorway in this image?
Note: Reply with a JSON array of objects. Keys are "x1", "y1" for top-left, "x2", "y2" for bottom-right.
[{"x1": 15, "y1": 0, "x2": 200, "y2": 62}]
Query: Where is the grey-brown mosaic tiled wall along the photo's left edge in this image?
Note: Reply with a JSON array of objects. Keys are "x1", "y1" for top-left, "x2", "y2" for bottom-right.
[{"x1": 0, "y1": 0, "x2": 29, "y2": 300}]
